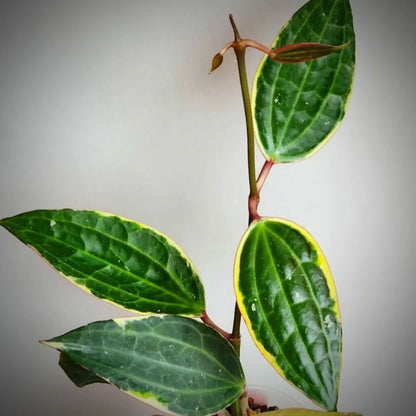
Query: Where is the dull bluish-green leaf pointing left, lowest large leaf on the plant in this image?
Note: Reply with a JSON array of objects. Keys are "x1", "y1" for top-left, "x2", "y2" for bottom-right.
[{"x1": 44, "y1": 315, "x2": 245, "y2": 416}]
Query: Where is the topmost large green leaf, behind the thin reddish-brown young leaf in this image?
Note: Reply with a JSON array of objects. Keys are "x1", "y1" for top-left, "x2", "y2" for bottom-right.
[{"x1": 253, "y1": 0, "x2": 355, "y2": 163}]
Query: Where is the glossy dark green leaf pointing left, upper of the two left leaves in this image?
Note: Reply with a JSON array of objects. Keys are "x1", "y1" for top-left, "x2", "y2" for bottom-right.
[{"x1": 0, "y1": 209, "x2": 205, "y2": 316}]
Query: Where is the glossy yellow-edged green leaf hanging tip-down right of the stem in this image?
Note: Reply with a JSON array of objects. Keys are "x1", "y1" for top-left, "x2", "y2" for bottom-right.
[{"x1": 235, "y1": 218, "x2": 342, "y2": 410}]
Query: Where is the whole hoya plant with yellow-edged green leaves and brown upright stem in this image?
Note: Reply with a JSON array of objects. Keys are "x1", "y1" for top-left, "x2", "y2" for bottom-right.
[{"x1": 0, "y1": 0, "x2": 355, "y2": 416}]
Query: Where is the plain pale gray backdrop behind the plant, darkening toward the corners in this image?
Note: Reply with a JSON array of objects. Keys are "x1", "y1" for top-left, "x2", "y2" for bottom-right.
[{"x1": 0, "y1": 0, "x2": 416, "y2": 416}]
